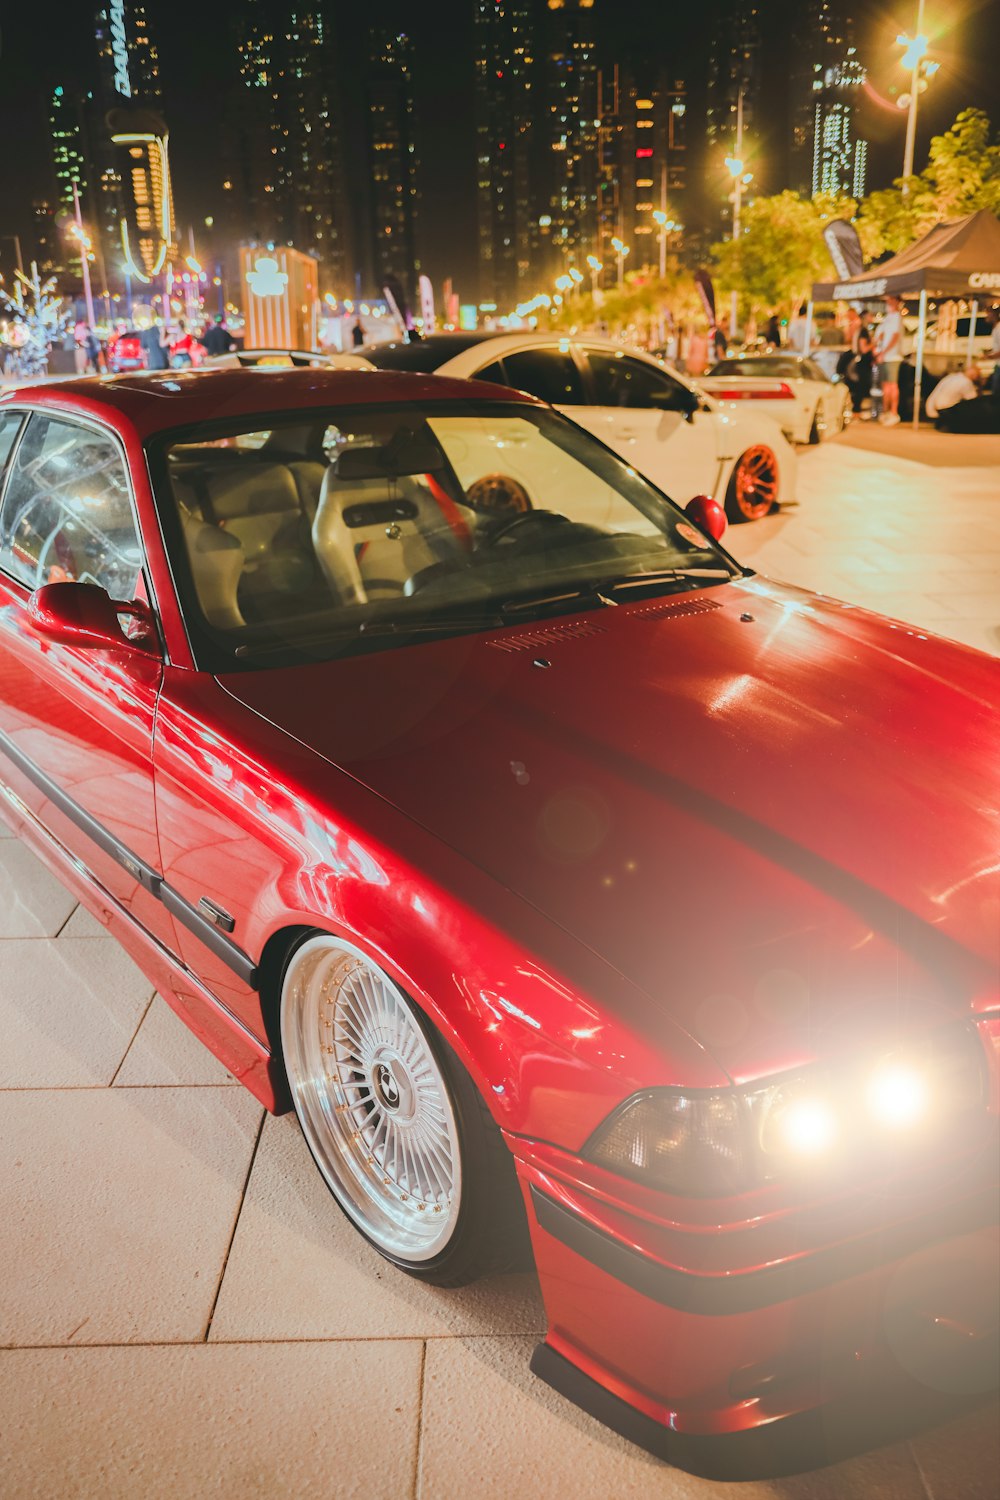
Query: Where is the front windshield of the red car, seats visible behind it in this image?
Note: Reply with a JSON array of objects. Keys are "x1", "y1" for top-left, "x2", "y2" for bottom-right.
[{"x1": 150, "y1": 402, "x2": 738, "y2": 671}]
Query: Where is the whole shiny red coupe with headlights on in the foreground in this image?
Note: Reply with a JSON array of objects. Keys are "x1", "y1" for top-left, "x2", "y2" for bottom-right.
[{"x1": 0, "y1": 369, "x2": 1000, "y2": 1473}]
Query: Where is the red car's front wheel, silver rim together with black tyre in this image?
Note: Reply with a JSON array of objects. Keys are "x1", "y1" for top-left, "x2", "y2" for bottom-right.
[{"x1": 280, "y1": 936, "x2": 520, "y2": 1286}]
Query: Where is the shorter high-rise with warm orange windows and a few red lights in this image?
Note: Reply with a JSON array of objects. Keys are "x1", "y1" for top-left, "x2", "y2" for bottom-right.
[{"x1": 597, "y1": 66, "x2": 687, "y2": 267}]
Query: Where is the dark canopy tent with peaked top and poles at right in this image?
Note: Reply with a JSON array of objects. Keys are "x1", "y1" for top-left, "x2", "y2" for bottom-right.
[{"x1": 810, "y1": 209, "x2": 1000, "y2": 426}]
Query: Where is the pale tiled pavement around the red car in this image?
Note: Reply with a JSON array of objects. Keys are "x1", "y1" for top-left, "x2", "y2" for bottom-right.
[{"x1": 0, "y1": 444, "x2": 1000, "y2": 1500}]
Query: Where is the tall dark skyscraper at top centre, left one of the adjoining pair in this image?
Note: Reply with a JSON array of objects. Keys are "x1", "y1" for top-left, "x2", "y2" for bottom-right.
[{"x1": 474, "y1": 0, "x2": 537, "y2": 311}]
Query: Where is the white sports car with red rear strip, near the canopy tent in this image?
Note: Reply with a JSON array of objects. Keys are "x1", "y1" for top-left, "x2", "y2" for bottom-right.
[{"x1": 697, "y1": 354, "x2": 850, "y2": 443}]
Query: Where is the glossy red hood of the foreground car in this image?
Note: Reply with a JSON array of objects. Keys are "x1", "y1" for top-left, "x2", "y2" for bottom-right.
[{"x1": 222, "y1": 578, "x2": 1000, "y2": 1080}]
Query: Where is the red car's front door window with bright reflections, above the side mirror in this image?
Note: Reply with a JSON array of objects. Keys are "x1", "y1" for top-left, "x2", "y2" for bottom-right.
[{"x1": 0, "y1": 413, "x2": 142, "y2": 600}]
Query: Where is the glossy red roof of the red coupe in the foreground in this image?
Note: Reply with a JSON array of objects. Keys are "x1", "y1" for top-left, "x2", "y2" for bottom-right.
[{"x1": 0, "y1": 366, "x2": 538, "y2": 438}]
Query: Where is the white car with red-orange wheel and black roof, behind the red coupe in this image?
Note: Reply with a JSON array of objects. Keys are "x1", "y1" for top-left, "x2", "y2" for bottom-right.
[{"x1": 352, "y1": 333, "x2": 796, "y2": 521}]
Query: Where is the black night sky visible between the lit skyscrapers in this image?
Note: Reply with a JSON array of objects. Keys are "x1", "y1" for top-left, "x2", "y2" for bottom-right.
[{"x1": 0, "y1": 0, "x2": 1000, "y2": 287}]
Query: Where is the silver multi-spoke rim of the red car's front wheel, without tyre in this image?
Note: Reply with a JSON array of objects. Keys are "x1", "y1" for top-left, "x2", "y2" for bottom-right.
[{"x1": 280, "y1": 936, "x2": 462, "y2": 1269}]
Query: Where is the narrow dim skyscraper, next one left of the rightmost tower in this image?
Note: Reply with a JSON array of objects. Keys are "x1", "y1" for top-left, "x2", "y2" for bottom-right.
[{"x1": 705, "y1": 0, "x2": 765, "y2": 219}]
